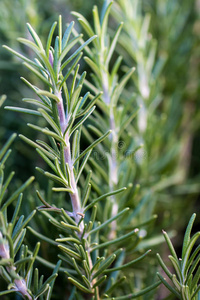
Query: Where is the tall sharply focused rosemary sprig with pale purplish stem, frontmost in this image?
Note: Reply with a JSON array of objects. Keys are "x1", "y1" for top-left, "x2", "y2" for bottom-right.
[{"x1": 2, "y1": 9, "x2": 160, "y2": 299}]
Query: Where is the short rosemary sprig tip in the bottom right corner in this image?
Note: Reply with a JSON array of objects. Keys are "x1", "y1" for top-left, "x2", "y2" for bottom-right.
[{"x1": 157, "y1": 214, "x2": 200, "y2": 300}]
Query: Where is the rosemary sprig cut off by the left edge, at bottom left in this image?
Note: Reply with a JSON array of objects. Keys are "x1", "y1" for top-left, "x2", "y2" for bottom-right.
[{"x1": 0, "y1": 132, "x2": 60, "y2": 300}]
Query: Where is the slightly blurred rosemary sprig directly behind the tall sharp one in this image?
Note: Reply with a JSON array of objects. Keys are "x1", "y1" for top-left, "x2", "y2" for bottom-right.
[{"x1": 73, "y1": 1, "x2": 162, "y2": 297}]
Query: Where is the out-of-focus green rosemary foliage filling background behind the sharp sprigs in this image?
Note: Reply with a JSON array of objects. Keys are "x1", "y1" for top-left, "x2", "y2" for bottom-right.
[{"x1": 0, "y1": 0, "x2": 200, "y2": 299}]
